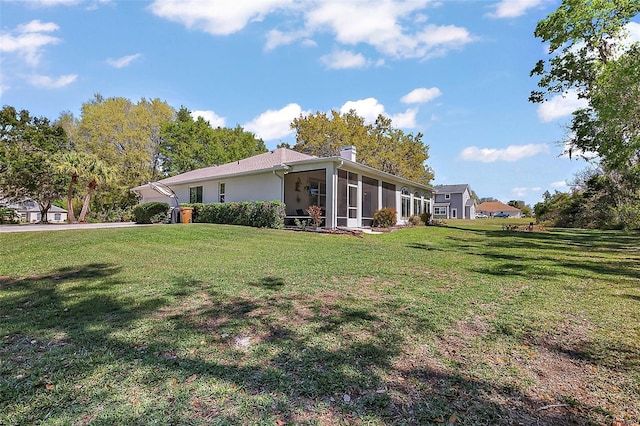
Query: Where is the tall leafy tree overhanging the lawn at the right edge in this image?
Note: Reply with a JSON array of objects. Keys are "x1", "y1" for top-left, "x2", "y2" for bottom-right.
[{"x1": 530, "y1": 0, "x2": 640, "y2": 227}]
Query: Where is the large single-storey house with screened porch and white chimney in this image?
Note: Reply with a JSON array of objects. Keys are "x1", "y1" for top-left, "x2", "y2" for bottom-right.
[{"x1": 132, "y1": 147, "x2": 433, "y2": 228}]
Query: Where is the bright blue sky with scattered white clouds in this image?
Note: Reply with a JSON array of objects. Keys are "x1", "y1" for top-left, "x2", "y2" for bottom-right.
[{"x1": 0, "y1": 0, "x2": 640, "y2": 206}]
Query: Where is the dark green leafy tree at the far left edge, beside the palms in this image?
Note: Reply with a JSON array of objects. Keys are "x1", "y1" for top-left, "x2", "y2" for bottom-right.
[{"x1": 0, "y1": 106, "x2": 71, "y2": 223}]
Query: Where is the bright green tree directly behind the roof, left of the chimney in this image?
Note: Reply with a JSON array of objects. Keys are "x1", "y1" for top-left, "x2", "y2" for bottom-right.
[{"x1": 159, "y1": 107, "x2": 267, "y2": 176}]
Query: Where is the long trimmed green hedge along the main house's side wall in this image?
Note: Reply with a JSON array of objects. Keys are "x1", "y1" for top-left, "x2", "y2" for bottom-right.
[{"x1": 182, "y1": 201, "x2": 286, "y2": 229}]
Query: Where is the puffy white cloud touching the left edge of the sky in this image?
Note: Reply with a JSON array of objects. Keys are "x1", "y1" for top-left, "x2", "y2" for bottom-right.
[{"x1": 0, "y1": 20, "x2": 60, "y2": 67}]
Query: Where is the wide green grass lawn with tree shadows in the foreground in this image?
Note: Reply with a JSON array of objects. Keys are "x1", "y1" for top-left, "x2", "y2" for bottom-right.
[{"x1": 0, "y1": 225, "x2": 640, "y2": 425}]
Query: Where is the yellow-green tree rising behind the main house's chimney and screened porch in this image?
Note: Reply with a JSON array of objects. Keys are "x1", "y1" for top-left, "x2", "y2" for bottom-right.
[{"x1": 291, "y1": 110, "x2": 433, "y2": 184}]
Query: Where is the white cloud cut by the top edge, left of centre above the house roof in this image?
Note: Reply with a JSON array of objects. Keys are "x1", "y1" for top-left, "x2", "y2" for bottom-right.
[{"x1": 149, "y1": 0, "x2": 294, "y2": 35}]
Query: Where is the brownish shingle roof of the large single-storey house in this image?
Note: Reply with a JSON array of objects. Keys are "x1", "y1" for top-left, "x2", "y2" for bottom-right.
[{"x1": 160, "y1": 148, "x2": 316, "y2": 185}]
